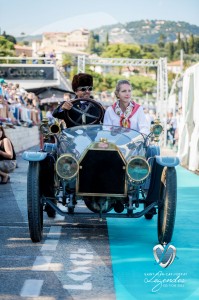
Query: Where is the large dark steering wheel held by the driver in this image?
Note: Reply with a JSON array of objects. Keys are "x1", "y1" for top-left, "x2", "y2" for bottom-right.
[{"x1": 66, "y1": 98, "x2": 104, "y2": 126}]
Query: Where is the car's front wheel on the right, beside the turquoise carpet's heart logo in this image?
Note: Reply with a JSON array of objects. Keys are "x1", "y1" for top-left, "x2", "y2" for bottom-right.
[{"x1": 158, "y1": 167, "x2": 177, "y2": 244}]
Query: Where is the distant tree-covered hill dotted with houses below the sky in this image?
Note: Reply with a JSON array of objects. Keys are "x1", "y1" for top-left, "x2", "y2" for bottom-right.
[{"x1": 93, "y1": 20, "x2": 199, "y2": 44}]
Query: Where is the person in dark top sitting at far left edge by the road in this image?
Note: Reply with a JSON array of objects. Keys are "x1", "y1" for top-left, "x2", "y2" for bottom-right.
[{"x1": 0, "y1": 125, "x2": 17, "y2": 184}]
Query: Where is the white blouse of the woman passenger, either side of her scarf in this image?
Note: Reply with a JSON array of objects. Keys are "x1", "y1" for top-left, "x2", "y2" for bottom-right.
[{"x1": 103, "y1": 106, "x2": 150, "y2": 134}]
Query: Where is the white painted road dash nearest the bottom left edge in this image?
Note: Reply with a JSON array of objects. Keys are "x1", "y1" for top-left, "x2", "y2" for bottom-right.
[{"x1": 20, "y1": 279, "x2": 44, "y2": 297}]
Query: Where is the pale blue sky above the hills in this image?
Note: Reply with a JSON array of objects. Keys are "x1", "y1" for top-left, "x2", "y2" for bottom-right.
[{"x1": 0, "y1": 0, "x2": 199, "y2": 36}]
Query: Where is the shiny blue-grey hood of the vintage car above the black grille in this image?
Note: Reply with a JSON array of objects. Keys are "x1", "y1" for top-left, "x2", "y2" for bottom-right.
[{"x1": 58, "y1": 125, "x2": 146, "y2": 159}]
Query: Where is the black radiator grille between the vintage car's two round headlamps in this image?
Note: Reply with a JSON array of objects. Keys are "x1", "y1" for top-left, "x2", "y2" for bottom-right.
[{"x1": 77, "y1": 150, "x2": 126, "y2": 196}]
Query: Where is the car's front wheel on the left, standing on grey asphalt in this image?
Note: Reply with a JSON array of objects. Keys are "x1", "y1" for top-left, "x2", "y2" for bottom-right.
[{"x1": 27, "y1": 162, "x2": 43, "y2": 243}]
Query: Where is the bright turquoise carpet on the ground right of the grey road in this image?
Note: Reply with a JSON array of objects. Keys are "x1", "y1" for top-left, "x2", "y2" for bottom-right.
[{"x1": 107, "y1": 166, "x2": 199, "y2": 300}]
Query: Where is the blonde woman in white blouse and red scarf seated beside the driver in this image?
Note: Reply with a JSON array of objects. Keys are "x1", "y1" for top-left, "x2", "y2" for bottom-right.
[{"x1": 103, "y1": 80, "x2": 150, "y2": 134}]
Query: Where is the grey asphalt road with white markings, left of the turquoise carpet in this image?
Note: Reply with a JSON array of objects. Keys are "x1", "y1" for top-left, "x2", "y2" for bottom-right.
[{"x1": 0, "y1": 149, "x2": 115, "y2": 300}]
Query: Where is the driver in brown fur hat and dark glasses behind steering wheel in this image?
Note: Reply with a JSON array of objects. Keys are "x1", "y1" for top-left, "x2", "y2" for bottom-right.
[{"x1": 52, "y1": 73, "x2": 103, "y2": 127}]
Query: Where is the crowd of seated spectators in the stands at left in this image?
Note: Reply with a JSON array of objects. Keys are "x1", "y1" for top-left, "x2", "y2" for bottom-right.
[{"x1": 0, "y1": 79, "x2": 42, "y2": 128}]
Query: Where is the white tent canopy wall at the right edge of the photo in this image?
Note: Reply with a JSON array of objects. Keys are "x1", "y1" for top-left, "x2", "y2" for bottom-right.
[{"x1": 178, "y1": 63, "x2": 199, "y2": 171}]
